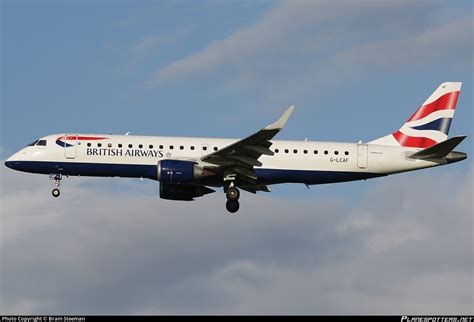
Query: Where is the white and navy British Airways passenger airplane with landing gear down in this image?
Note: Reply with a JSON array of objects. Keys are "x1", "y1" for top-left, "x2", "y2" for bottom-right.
[{"x1": 5, "y1": 82, "x2": 467, "y2": 213}]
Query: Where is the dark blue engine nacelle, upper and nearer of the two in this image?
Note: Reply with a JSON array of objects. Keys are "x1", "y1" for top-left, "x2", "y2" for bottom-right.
[{"x1": 157, "y1": 160, "x2": 202, "y2": 184}]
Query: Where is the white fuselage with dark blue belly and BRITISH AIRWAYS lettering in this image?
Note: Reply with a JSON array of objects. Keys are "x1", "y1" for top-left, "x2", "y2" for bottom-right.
[{"x1": 7, "y1": 134, "x2": 446, "y2": 185}]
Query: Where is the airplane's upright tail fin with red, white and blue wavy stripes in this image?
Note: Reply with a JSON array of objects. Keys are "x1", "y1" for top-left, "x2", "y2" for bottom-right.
[{"x1": 369, "y1": 82, "x2": 462, "y2": 148}]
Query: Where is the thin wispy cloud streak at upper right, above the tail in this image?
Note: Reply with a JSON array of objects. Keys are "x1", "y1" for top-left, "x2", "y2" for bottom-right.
[{"x1": 147, "y1": 1, "x2": 473, "y2": 97}]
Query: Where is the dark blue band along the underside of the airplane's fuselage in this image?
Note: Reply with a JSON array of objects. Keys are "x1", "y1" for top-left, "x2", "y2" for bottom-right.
[{"x1": 5, "y1": 161, "x2": 383, "y2": 184}]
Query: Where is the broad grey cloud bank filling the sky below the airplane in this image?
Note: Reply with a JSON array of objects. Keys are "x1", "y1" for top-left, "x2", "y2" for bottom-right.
[{"x1": 0, "y1": 164, "x2": 474, "y2": 314}]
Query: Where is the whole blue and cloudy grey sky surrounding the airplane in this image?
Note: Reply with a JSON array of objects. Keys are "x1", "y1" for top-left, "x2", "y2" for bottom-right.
[{"x1": 0, "y1": 0, "x2": 474, "y2": 314}]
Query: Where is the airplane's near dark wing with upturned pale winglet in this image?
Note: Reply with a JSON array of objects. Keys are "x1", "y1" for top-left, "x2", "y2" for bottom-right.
[{"x1": 201, "y1": 105, "x2": 295, "y2": 185}]
